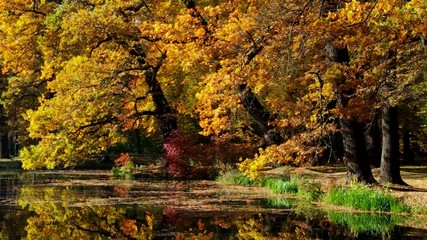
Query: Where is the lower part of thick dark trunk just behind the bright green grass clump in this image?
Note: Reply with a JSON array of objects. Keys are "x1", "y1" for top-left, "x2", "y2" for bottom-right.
[{"x1": 340, "y1": 118, "x2": 376, "y2": 184}]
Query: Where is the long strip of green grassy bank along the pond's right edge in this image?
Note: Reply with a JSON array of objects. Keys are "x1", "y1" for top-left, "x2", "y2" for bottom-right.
[{"x1": 217, "y1": 170, "x2": 418, "y2": 213}]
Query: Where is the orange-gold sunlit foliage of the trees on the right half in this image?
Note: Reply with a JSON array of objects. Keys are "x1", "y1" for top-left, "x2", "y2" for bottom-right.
[{"x1": 203, "y1": 0, "x2": 425, "y2": 174}]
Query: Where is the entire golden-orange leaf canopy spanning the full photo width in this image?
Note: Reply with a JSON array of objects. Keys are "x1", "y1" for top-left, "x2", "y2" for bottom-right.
[{"x1": 0, "y1": 0, "x2": 427, "y2": 169}]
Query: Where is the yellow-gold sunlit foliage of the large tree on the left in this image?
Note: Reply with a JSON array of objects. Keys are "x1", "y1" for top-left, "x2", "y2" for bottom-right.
[{"x1": 2, "y1": 0, "x2": 204, "y2": 168}]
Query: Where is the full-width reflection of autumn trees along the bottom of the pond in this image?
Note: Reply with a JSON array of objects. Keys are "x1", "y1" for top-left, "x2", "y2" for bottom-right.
[{"x1": 0, "y1": 186, "x2": 408, "y2": 240}]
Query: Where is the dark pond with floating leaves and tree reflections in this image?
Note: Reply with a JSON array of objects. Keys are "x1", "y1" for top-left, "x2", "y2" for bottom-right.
[{"x1": 0, "y1": 170, "x2": 427, "y2": 239}]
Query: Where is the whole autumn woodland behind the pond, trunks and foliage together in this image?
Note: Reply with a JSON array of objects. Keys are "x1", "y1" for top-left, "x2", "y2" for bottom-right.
[{"x1": 0, "y1": 0, "x2": 427, "y2": 184}]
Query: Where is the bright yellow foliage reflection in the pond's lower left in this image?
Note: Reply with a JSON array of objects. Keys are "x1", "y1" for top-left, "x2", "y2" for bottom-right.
[{"x1": 18, "y1": 187, "x2": 153, "y2": 239}]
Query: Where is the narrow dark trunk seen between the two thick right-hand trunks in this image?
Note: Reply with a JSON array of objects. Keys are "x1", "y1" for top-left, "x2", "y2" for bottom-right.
[{"x1": 366, "y1": 116, "x2": 381, "y2": 168}]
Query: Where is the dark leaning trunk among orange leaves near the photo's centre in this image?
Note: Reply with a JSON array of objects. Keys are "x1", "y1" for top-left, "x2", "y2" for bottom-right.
[{"x1": 238, "y1": 84, "x2": 283, "y2": 146}]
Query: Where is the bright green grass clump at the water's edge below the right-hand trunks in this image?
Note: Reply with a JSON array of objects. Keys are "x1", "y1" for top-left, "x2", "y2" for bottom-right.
[{"x1": 324, "y1": 184, "x2": 410, "y2": 212}]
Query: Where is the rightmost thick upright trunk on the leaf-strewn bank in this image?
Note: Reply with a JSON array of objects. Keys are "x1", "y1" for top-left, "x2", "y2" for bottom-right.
[{"x1": 380, "y1": 106, "x2": 406, "y2": 185}]
